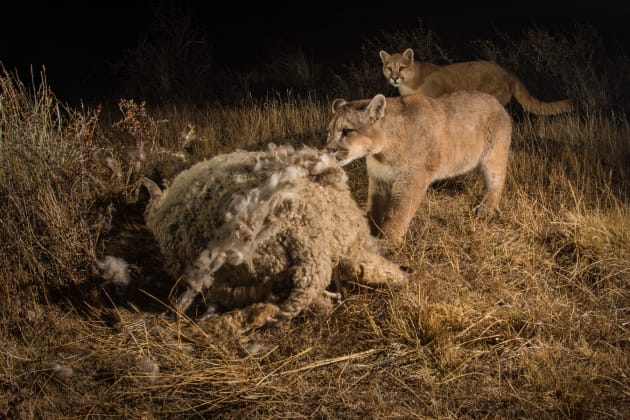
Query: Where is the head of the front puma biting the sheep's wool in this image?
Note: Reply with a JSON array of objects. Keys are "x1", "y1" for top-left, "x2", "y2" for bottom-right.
[{"x1": 326, "y1": 93, "x2": 387, "y2": 166}]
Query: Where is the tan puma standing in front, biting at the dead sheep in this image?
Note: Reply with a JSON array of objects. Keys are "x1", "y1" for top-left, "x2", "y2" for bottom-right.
[{"x1": 326, "y1": 91, "x2": 512, "y2": 243}]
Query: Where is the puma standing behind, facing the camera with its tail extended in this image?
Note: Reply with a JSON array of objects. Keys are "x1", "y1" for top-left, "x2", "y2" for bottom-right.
[{"x1": 379, "y1": 48, "x2": 572, "y2": 115}]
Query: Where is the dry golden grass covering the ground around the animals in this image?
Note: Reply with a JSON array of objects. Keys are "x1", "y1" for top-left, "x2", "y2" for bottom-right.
[{"x1": 0, "y1": 24, "x2": 630, "y2": 418}]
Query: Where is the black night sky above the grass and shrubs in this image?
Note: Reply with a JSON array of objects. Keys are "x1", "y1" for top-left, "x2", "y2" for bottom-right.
[{"x1": 0, "y1": 0, "x2": 630, "y2": 102}]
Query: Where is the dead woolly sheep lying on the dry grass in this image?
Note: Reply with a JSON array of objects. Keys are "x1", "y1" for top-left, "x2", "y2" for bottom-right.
[{"x1": 144, "y1": 145, "x2": 406, "y2": 333}]
